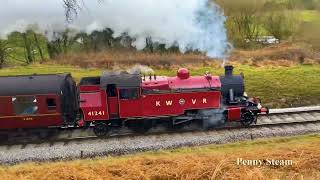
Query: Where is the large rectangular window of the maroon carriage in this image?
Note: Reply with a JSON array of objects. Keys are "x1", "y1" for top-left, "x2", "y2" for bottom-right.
[{"x1": 12, "y1": 96, "x2": 38, "y2": 115}]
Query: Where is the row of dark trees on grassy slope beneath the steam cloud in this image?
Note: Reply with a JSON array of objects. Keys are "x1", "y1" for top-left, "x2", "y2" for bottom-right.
[{"x1": 0, "y1": 28, "x2": 184, "y2": 69}]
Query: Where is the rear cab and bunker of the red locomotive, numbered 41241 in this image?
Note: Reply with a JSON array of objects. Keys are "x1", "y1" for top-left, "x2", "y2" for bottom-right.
[{"x1": 79, "y1": 72, "x2": 142, "y2": 122}]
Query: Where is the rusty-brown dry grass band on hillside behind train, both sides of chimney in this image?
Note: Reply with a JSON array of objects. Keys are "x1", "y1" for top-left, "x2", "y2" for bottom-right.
[{"x1": 56, "y1": 43, "x2": 320, "y2": 69}]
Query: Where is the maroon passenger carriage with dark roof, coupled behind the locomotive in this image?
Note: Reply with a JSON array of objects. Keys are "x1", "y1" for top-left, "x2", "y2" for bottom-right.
[{"x1": 0, "y1": 74, "x2": 79, "y2": 131}]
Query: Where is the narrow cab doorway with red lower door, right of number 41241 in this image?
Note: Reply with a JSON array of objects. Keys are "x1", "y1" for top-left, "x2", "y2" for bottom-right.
[{"x1": 107, "y1": 84, "x2": 119, "y2": 118}]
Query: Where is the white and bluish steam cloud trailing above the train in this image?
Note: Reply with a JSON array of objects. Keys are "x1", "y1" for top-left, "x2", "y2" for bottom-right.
[{"x1": 0, "y1": 0, "x2": 230, "y2": 58}]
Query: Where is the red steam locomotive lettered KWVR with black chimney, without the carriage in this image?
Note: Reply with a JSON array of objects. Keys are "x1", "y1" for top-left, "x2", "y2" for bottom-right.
[{"x1": 80, "y1": 66, "x2": 267, "y2": 136}]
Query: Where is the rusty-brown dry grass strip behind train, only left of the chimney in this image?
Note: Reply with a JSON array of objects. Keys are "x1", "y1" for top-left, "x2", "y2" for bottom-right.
[{"x1": 56, "y1": 51, "x2": 213, "y2": 69}]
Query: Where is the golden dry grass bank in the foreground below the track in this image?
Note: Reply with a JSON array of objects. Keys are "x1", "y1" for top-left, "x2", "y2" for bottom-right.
[{"x1": 0, "y1": 134, "x2": 320, "y2": 180}]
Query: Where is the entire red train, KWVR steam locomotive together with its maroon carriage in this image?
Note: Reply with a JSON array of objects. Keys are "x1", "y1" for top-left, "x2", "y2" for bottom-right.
[{"x1": 0, "y1": 66, "x2": 268, "y2": 136}]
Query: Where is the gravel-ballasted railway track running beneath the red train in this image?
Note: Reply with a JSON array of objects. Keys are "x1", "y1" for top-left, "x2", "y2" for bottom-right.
[{"x1": 0, "y1": 106, "x2": 320, "y2": 163}]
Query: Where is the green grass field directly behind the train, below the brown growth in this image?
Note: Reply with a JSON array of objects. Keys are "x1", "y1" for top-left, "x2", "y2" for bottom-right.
[{"x1": 0, "y1": 64, "x2": 320, "y2": 108}]
